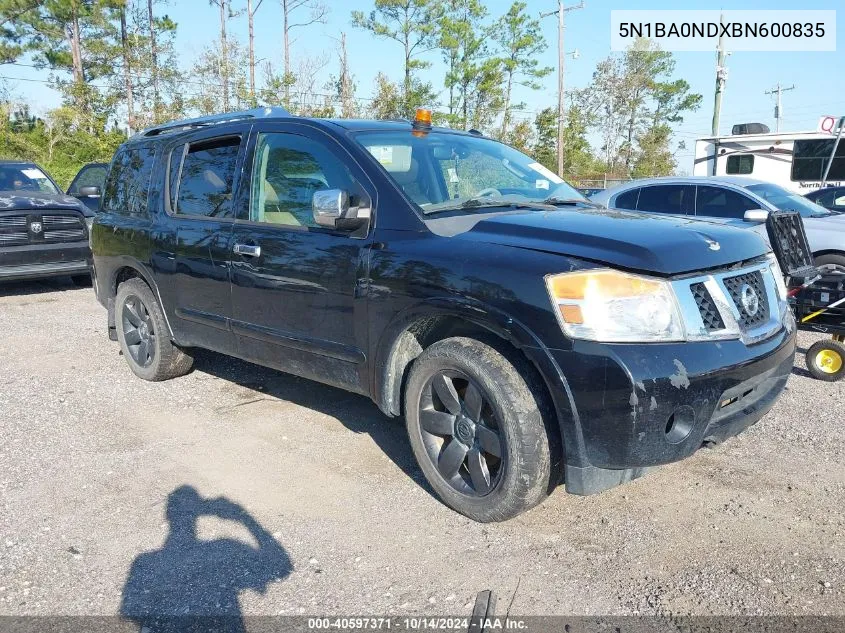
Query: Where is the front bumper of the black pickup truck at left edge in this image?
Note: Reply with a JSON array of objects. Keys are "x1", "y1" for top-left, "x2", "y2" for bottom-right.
[{"x1": 0, "y1": 240, "x2": 91, "y2": 281}]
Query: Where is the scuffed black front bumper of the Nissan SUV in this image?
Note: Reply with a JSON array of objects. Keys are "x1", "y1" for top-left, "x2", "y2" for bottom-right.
[{"x1": 550, "y1": 328, "x2": 795, "y2": 494}]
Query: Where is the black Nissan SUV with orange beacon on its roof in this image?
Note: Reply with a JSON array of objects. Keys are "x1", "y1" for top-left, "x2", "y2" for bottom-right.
[{"x1": 93, "y1": 109, "x2": 795, "y2": 521}]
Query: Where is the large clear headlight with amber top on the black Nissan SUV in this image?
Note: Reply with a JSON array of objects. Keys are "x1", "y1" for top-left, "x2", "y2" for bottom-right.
[{"x1": 546, "y1": 269, "x2": 684, "y2": 343}]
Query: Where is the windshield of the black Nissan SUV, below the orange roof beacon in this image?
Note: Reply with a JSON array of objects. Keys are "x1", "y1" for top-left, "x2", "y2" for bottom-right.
[{"x1": 356, "y1": 129, "x2": 591, "y2": 214}]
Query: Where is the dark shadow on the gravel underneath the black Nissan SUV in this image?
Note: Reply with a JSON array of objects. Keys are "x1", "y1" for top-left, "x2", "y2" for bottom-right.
[{"x1": 194, "y1": 350, "x2": 426, "y2": 486}]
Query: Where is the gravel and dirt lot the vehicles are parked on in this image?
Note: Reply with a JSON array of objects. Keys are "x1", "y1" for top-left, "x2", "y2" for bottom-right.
[{"x1": 0, "y1": 281, "x2": 845, "y2": 615}]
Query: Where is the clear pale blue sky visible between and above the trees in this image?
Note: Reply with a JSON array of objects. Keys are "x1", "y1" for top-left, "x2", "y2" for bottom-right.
[{"x1": 0, "y1": 0, "x2": 845, "y2": 171}]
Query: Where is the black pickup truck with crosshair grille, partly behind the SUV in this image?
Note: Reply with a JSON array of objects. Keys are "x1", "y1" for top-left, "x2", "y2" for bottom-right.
[{"x1": 0, "y1": 161, "x2": 94, "y2": 285}]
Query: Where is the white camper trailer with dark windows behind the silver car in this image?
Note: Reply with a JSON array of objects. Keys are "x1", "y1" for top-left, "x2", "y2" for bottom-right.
[{"x1": 693, "y1": 116, "x2": 845, "y2": 194}]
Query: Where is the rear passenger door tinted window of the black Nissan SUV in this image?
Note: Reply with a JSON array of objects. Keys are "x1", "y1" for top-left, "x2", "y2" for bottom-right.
[{"x1": 176, "y1": 138, "x2": 241, "y2": 218}]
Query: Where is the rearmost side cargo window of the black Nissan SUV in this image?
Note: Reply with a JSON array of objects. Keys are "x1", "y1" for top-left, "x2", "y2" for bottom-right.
[{"x1": 101, "y1": 147, "x2": 155, "y2": 216}]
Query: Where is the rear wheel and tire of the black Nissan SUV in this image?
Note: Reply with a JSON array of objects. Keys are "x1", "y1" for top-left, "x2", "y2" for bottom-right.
[{"x1": 114, "y1": 278, "x2": 194, "y2": 382}]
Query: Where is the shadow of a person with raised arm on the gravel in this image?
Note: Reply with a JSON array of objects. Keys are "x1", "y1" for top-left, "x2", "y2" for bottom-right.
[{"x1": 120, "y1": 486, "x2": 293, "y2": 633}]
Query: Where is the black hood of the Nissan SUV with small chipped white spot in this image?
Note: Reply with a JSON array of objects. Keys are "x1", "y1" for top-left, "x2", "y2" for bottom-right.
[{"x1": 454, "y1": 208, "x2": 769, "y2": 275}]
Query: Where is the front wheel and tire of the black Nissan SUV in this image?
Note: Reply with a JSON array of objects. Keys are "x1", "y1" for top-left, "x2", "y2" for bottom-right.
[{"x1": 403, "y1": 338, "x2": 559, "y2": 523}]
